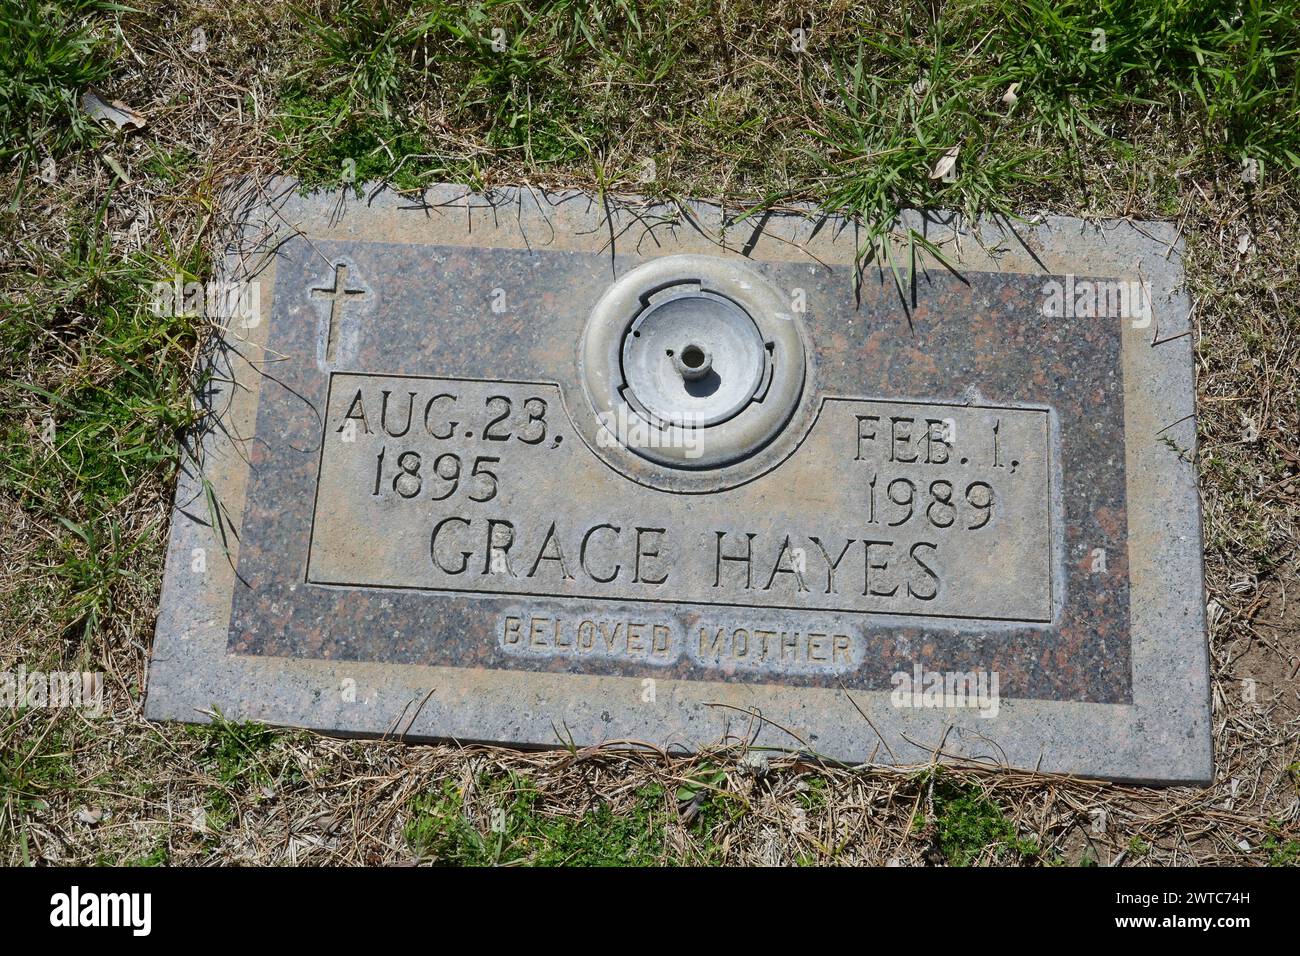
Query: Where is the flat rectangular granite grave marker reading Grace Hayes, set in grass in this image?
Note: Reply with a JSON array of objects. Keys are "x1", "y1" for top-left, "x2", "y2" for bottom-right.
[{"x1": 147, "y1": 181, "x2": 1212, "y2": 783}]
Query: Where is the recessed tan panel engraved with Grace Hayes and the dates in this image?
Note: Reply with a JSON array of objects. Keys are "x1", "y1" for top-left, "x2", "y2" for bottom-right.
[{"x1": 308, "y1": 372, "x2": 1053, "y2": 620}]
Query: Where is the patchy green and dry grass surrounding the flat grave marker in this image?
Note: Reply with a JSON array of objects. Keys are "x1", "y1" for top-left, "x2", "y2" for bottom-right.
[{"x1": 0, "y1": 0, "x2": 1300, "y2": 865}]
